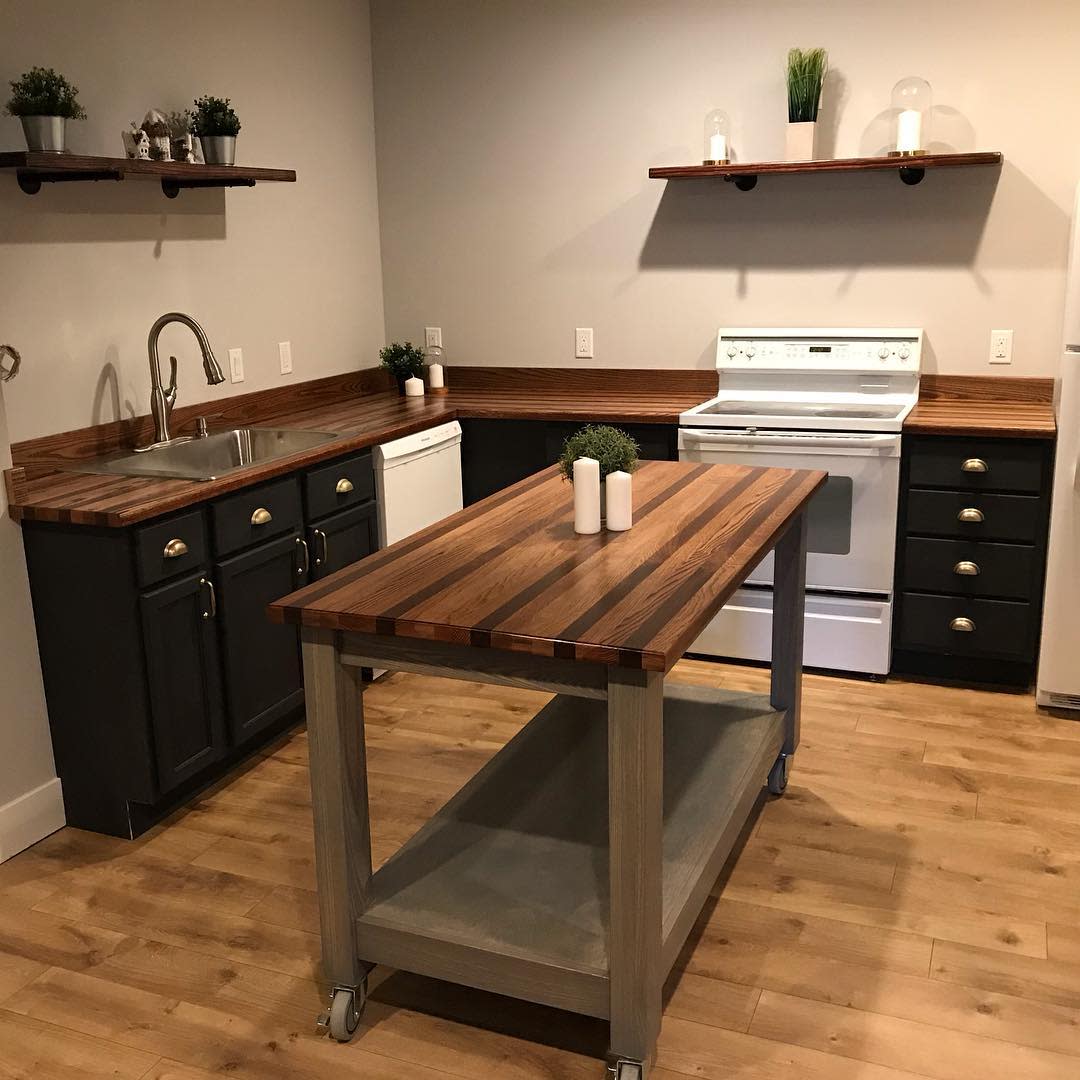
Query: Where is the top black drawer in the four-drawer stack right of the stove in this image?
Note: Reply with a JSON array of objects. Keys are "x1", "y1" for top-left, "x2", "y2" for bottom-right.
[{"x1": 908, "y1": 438, "x2": 1045, "y2": 494}]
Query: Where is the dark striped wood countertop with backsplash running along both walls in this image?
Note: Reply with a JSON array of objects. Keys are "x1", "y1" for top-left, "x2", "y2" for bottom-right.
[{"x1": 4, "y1": 367, "x2": 1055, "y2": 528}]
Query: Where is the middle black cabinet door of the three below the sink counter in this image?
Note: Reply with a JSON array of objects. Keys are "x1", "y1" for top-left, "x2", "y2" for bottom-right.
[{"x1": 214, "y1": 536, "x2": 307, "y2": 745}]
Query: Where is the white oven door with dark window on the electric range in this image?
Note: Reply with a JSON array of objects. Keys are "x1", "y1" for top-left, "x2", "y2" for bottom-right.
[{"x1": 679, "y1": 428, "x2": 900, "y2": 594}]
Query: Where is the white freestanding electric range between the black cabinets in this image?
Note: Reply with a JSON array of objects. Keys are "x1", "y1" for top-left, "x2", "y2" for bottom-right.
[{"x1": 679, "y1": 327, "x2": 922, "y2": 675}]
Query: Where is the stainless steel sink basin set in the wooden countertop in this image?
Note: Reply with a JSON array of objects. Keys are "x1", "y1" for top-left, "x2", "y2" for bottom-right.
[{"x1": 71, "y1": 428, "x2": 338, "y2": 480}]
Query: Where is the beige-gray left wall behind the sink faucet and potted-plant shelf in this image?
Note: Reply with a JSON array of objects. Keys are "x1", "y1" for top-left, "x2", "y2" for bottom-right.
[{"x1": 0, "y1": 0, "x2": 383, "y2": 441}]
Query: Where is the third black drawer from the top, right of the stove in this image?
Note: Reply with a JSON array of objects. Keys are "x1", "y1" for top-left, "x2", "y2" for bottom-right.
[{"x1": 903, "y1": 537, "x2": 1038, "y2": 600}]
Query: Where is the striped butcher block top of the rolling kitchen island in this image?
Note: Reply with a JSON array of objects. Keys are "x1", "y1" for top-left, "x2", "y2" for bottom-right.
[{"x1": 270, "y1": 461, "x2": 826, "y2": 672}]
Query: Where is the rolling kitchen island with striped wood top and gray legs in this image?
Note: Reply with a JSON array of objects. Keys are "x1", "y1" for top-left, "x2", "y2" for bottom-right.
[{"x1": 270, "y1": 461, "x2": 825, "y2": 1080}]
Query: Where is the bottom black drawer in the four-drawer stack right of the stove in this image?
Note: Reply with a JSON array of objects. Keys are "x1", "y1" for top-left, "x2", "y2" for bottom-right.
[{"x1": 896, "y1": 593, "x2": 1036, "y2": 660}]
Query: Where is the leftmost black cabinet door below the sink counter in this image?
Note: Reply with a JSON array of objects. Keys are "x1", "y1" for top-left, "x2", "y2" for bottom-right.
[{"x1": 139, "y1": 573, "x2": 226, "y2": 793}]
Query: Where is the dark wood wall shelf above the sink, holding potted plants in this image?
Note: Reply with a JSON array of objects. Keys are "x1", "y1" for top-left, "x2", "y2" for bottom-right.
[{"x1": 0, "y1": 150, "x2": 296, "y2": 199}]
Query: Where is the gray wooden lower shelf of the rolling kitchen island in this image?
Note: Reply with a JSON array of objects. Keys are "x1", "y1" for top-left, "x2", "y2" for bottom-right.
[{"x1": 356, "y1": 684, "x2": 784, "y2": 1018}]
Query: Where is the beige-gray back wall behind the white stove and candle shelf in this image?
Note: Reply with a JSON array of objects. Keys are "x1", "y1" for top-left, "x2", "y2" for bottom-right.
[{"x1": 373, "y1": 0, "x2": 1080, "y2": 376}]
